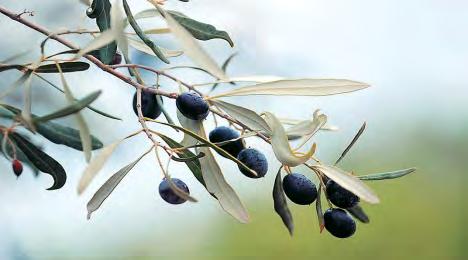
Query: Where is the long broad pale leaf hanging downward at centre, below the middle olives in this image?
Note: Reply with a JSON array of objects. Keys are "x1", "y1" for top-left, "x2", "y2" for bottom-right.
[{"x1": 172, "y1": 116, "x2": 250, "y2": 223}]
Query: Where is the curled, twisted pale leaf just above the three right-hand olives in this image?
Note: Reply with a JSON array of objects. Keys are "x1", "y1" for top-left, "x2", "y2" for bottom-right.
[{"x1": 265, "y1": 112, "x2": 316, "y2": 167}]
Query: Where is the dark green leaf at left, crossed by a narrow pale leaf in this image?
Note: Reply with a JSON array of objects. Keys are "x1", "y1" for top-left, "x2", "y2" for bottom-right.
[{"x1": 36, "y1": 121, "x2": 102, "y2": 151}]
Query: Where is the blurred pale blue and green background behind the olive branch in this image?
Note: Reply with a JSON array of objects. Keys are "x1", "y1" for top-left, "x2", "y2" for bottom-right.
[{"x1": 0, "y1": 0, "x2": 468, "y2": 259}]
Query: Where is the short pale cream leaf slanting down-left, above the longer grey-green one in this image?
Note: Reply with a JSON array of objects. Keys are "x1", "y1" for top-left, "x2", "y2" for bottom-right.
[{"x1": 77, "y1": 139, "x2": 123, "y2": 194}]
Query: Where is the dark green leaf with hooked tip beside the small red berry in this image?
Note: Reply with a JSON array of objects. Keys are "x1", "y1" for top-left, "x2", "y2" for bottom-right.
[{"x1": 10, "y1": 133, "x2": 67, "y2": 190}]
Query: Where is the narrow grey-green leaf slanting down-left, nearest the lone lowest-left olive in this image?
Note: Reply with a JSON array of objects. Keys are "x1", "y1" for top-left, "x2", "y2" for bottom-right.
[{"x1": 86, "y1": 147, "x2": 153, "y2": 219}]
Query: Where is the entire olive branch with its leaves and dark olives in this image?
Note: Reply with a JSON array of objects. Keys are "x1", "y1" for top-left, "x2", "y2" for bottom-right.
[{"x1": 0, "y1": 0, "x2": 415, "y2": 240}]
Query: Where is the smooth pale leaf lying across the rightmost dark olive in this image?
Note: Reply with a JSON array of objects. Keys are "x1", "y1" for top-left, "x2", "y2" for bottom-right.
[{"x1": 311, "y1": 165, "x2": 380, "y2": 204}]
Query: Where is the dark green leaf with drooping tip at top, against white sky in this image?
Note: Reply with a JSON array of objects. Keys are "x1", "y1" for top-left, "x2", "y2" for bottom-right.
[{"x1": 167, "y1": 11, "x2": 234, "y2": 47}]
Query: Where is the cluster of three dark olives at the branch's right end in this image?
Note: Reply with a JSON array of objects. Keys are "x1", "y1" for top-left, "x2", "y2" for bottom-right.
[{"x1": 283, "y1": 173, "x2": 359, "y2": 238}]
